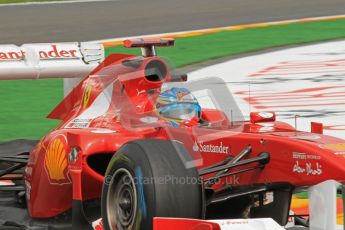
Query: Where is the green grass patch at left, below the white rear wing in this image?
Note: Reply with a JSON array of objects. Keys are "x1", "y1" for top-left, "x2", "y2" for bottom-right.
[{"x1": 0, "y1": 79, "x2": 63, "y2": 140}]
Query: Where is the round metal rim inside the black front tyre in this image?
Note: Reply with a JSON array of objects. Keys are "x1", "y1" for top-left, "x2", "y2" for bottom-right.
[{"x1": 106, "y1": 168, "x2": 137, "y2": 230}]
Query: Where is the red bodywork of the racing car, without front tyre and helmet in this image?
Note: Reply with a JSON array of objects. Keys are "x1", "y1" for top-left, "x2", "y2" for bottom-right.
[{"x1": 3, "y1": 39, "x2": 345, "y2": 228}]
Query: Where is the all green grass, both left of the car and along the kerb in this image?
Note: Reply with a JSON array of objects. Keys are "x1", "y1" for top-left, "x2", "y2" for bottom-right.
[{"x1": 0, "y1": 18, "x2": 345, "y2": 140}]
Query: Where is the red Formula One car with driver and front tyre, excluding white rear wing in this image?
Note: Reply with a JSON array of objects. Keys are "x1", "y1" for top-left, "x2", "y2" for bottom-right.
[{"x1": 0, "y1": 39, "x2": 345, "y2": 230}]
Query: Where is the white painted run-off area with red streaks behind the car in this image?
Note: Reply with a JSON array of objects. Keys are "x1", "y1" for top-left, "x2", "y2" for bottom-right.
[{"x1": 188, "y1": 40, "x2": 345, "y2": 139}]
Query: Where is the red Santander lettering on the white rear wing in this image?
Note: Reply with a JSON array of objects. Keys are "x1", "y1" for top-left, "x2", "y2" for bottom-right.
[{"x1": 0, "y1": 44, "x2": 81, "y2": 61}]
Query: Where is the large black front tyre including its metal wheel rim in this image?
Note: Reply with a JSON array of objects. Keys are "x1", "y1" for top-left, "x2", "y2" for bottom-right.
[{"x1": 102, "y1": 139, "x2": 203, "y2": 230}]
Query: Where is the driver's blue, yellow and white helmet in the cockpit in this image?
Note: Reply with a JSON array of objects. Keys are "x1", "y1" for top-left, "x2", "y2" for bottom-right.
[{"x1": 155, "y1": 87, "x2": 201, "y2": 127}]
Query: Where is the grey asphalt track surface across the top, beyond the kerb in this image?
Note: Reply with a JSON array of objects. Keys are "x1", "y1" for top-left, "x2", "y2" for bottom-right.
[{"x1": 0, "y1": 0, "x2": 345, "y2": 45}]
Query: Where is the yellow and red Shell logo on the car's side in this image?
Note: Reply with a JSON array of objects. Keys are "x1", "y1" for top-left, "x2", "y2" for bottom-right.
[{"x1": 45, "y1": 137, "x2": 69, "y2": 183}]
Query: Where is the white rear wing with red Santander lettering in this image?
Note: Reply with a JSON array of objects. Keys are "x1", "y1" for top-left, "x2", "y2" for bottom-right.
[{"x1": 0, "y1": 42, "x2": 104, "y2": 94}]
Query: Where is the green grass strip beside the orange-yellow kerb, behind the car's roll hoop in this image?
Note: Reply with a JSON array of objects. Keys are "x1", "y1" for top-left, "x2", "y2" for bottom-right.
[{"x1": 107, "y1": 19, "x2": 345, "y2": 67}]
